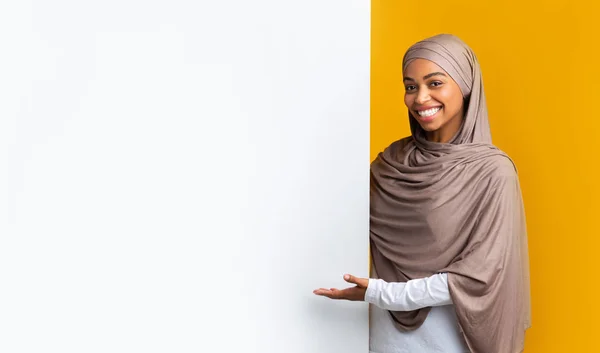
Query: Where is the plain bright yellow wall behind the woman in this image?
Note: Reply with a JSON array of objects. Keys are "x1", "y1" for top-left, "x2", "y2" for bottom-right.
[{"x1": 371, "y1": 0, "x2": 600, "y2": 353}]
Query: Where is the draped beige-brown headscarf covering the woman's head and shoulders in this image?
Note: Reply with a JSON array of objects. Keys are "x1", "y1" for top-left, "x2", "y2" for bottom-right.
[{"x1": 370, "y1": 34, "x2": 531, "y2": 353}]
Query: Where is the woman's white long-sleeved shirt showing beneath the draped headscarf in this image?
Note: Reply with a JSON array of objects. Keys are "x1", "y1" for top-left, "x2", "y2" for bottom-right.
[{"x1": 365, "y1": 270, "x2": 469, "y2": 353}]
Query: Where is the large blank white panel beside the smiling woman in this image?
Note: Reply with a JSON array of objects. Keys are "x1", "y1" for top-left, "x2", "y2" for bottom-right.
[{"x1": 0, "y1": 0, "x2": 370, "y2": 353}]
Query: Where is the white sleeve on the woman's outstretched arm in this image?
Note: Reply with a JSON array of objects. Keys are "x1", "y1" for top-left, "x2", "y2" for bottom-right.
[{"x1": 365, "y1": 273, "x2": 452, "y2": 311}]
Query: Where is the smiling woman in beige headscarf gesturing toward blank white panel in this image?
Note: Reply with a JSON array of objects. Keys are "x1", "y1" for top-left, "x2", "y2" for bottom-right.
[{"x1": 315, "y1": 34, "x2": 531, "y2": 353}]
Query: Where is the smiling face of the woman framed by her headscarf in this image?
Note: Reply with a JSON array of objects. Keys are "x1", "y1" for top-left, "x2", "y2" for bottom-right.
[{"x1": 404, "y1": 59, "x2": 464, "y2": 142}]
